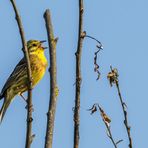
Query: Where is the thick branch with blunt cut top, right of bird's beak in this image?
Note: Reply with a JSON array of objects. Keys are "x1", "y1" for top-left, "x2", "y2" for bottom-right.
[{"x1": 44, "y1": 9, "x2": 58, "y2": 148}]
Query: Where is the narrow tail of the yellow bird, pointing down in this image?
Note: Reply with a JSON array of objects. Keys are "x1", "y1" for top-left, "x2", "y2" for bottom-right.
[{"x1": 0, "y1": 99, "x2": 11, "y2": 123}]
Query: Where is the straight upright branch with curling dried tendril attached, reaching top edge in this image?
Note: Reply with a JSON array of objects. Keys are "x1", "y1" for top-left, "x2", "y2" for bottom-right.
[{"x1": 74, "y1": 0, "x2": 84, "y2": 148}]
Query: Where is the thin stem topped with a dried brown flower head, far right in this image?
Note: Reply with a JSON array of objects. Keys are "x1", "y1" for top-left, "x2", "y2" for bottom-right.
[{"x1": 107, "y1": 67, "x2": 132, "y2": 148}]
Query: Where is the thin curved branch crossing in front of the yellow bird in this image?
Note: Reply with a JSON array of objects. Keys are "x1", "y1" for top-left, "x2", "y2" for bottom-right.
[{"x1": 10, "y1": 0, "x2": 35, "y2": 148}]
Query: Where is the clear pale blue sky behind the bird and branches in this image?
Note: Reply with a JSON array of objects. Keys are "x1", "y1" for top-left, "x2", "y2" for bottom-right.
[{"x1": 0, "y1": 0, "x2": 148, "y2": 148}]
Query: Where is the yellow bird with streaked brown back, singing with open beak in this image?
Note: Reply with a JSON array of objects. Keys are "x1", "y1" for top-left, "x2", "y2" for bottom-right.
[{"x1": 0, "y1": 40, "x2": 47, "y2": 122}]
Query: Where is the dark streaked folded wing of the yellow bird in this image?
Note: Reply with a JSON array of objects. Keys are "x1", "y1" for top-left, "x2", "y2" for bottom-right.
[{"x1": 0, "y1": 58, "x2": 26, "y2": 98}]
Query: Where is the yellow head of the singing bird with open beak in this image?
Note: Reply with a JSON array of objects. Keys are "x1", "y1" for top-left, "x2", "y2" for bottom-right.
[{"x1": 27, "y1": 40, "x2": 47, "y2": 54}]
